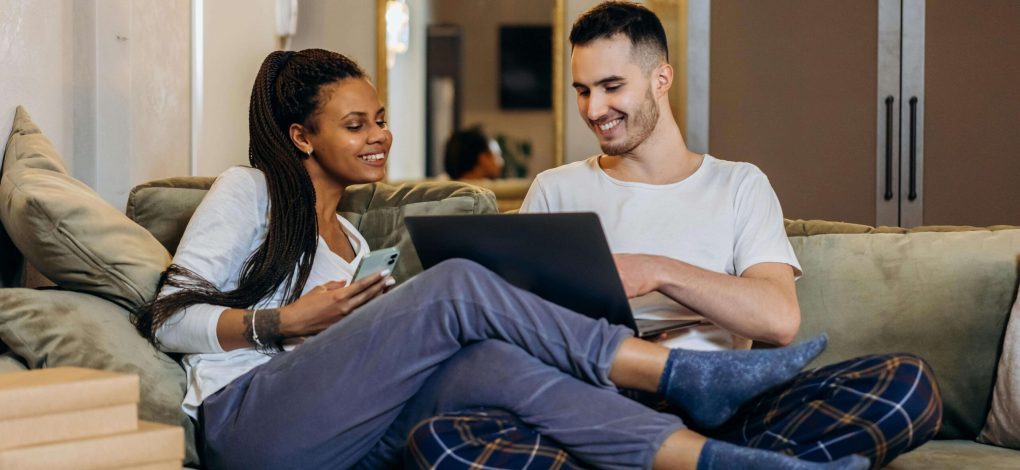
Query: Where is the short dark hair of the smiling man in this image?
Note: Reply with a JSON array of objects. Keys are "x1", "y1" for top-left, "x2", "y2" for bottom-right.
[{"x1": 570, "y1": 0, "x2": 669, "y2": 62}]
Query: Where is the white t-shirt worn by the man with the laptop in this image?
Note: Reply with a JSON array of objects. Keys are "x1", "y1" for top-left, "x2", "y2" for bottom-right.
[{"x1": 520, "y1": 155, "x2": 801, "y2": 350}]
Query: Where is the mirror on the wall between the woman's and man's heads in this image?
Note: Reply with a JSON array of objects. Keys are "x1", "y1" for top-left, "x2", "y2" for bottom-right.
[{"x1": 379, "y1": 0, "x2": 563, "y2": 179}]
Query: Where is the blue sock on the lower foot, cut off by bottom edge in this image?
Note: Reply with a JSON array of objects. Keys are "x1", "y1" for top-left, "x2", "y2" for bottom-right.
[{"x1": 698, "y1": 439, "x2": 871, "y2": 470}]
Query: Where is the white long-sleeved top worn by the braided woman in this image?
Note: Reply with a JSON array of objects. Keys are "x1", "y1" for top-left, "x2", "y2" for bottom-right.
[{"x1": 156, "y1": 166, "x2": 368, "y2": 418}]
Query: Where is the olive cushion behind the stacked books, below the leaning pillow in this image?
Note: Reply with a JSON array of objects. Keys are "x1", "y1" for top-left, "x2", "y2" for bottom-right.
[{"x1": 0, "y1": 289, "x2": 197, "y2": 462}]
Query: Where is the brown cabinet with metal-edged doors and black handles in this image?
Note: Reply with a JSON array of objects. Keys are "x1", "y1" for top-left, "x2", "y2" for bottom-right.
[{"x1": 705, "y1": 0, "x2": 1020, "y2": 226}]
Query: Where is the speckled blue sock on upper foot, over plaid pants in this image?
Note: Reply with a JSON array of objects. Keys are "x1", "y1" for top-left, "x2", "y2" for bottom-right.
[{"x1": 659, "y1": 333, "x2": 828, "y2": 429}]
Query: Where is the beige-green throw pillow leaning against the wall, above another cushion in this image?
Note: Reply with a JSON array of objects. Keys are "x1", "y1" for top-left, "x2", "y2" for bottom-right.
[{"x1": 0, "y1": 108, "x2": 170, "y2": 310}]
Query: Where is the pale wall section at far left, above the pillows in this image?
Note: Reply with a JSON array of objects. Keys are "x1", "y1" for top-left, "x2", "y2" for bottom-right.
[{"x1": 0, "y1": 0, "x2": 191, "y2": 208}]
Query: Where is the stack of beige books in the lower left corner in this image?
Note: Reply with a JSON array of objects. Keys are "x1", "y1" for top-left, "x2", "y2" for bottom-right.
[{"x1": 0, "y1": 367, "x2": 185, "y2": 470}]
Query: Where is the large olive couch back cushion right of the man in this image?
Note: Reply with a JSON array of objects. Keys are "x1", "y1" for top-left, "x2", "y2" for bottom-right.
[{"x1": 789, "y1": 229, "x2": 1020, "y2": 439}]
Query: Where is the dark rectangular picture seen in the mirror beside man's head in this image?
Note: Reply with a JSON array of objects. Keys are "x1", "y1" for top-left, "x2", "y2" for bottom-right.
[{"x1": 500, "y1": 24, "x2": 553, "y2": 109}]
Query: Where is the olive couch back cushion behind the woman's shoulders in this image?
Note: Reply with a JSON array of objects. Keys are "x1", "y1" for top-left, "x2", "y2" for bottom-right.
[{"x1": 126, "y1": 176, "x2": 497, "y2": 281}]
